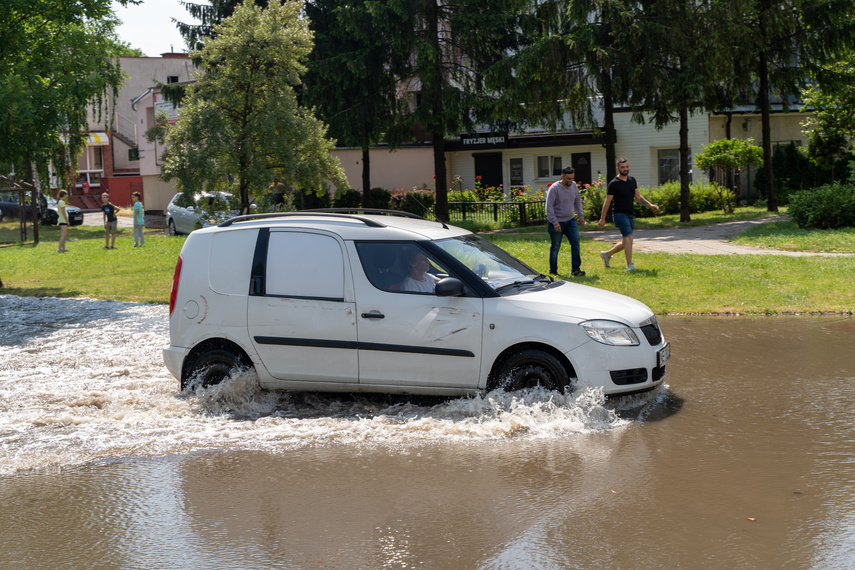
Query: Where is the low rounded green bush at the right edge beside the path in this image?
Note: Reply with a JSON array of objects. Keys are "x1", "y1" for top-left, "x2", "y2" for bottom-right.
[{"x1": 788, "y1": 182, "x2": 855, "y2": 230}]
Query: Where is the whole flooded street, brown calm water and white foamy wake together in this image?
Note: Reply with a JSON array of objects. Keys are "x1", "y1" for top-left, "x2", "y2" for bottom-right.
[{"x1": 0, "y1": 296, "x2": 855, "y2": 569}]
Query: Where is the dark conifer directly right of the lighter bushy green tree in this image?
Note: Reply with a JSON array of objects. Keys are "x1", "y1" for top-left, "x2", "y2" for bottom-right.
[{"x1": 301, "y1": 0, "x2": 405, "y2": 206}]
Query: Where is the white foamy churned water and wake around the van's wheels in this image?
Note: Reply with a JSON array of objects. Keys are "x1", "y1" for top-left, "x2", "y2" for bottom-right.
[{"x1": 0, "y1": 295, "x2": 664, "y2": 474}]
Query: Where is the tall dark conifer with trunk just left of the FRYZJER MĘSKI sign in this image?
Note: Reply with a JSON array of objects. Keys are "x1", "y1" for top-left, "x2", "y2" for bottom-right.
[{"x1": 360, "y1": 0, "x2": 527, "y2": 220}]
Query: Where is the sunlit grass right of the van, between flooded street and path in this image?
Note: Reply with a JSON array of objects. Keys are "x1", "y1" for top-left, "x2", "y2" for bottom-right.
[{"x1": 489, "y1": 232, "x2": 855, "y2": 314}]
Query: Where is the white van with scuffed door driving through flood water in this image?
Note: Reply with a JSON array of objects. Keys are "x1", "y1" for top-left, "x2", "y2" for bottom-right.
[{"x1": 163, "y1": 210, "x2": 671, "y2": 395}]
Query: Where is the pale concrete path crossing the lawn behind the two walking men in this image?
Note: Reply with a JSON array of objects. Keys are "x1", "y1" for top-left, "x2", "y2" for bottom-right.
[{"x1": 581, "y1": 216, "x2": 855, "y2": 257}]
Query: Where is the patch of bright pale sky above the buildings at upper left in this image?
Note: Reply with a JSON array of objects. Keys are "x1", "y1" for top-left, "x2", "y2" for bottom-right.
[{"x1": 113, "y1": 0, "x2": 204, "y2": 57}]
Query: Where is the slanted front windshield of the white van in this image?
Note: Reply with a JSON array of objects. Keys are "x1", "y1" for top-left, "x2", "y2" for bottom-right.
[{"x1": 434, "y1": 234, "x2": 546, "y2": 291}]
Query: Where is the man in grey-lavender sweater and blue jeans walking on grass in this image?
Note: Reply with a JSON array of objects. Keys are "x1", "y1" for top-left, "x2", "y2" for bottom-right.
[{"x1": 546, "y1": 166, "x2": 585, "y2": 277}]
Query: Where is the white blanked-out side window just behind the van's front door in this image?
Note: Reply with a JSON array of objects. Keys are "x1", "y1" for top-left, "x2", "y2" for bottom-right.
[{"x1": 265, "y1": 232, "x2": 344, "y2": 300}]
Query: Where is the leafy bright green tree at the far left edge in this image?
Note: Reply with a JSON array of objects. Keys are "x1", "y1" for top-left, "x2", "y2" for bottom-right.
[{"x1": 0, "y1": 0, "x2": 130, "y2": 242}]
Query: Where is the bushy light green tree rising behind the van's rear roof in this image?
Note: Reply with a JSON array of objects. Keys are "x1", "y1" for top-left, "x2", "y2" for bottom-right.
[{"x1": 161, "y1": 0, "x2": 347, "y2": 213}]
